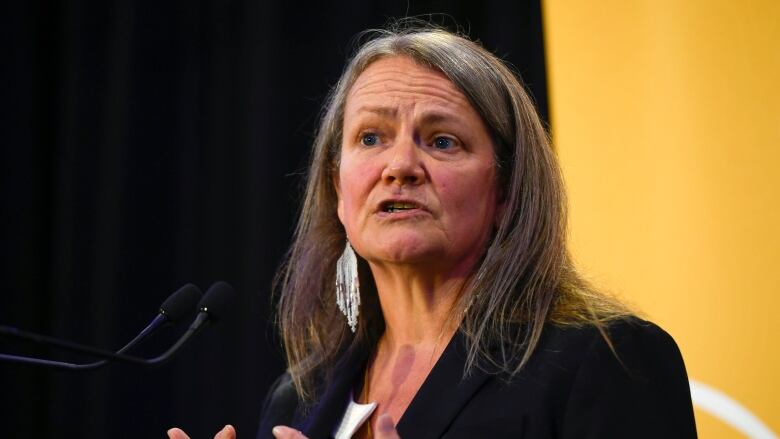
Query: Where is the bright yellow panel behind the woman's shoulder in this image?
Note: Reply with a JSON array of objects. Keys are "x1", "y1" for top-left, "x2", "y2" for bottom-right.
[{"x1": 543, "y1": 0, "x2": 780, "y2": 437}]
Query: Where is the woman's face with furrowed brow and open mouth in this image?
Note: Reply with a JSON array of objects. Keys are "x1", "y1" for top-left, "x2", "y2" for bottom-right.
[{"x1": 336, "y1": 56, "x2": 498, "y2": 273}]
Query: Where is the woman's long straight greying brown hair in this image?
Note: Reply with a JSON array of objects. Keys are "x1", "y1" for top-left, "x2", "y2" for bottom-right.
[{"x1": 277, "y1": 22, "x2": 628, "y2": 399}]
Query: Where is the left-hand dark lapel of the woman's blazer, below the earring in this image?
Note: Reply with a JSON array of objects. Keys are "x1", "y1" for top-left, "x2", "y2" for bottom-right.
[{"x1": 297, "y1": 348, "x2": 368, "y2": 439}]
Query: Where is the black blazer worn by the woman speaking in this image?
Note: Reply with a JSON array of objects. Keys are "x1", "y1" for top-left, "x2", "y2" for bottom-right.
[{"x1": 257, "y1": 319, "x2": 696, "y2": 439}]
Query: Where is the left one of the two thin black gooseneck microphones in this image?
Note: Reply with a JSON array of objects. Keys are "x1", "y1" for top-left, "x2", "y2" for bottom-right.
[{"x1": 0, "y1": 284, "x2": 201, "y2": 370}]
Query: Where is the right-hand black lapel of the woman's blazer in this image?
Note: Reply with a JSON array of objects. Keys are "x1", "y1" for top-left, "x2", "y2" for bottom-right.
[{"x1": 396, "y1": 331, "x2": 490, "y2": 439}]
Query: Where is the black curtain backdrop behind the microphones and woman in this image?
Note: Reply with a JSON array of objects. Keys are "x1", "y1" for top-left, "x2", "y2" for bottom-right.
[{"x1": 0, "y1": 0, "x2": 547, "y2": 438}]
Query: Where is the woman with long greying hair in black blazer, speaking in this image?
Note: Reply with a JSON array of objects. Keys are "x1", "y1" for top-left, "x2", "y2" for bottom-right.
[{"x1": 172, "y1": 24, "x2": 696, "y2": 439}]
